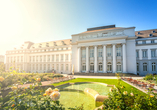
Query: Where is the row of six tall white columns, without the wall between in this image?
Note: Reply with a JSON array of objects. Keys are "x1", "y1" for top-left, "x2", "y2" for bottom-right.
[{"x1": 78, "y1": 43, "x2": 127, "y2": 73}]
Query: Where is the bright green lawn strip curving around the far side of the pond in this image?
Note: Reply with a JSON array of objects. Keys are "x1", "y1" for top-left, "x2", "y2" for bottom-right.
[{"x1": 52, "y1": 78, "x2": 146, "y2": 95}]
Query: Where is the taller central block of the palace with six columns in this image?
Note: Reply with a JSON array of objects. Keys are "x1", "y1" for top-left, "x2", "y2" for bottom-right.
[{"x1": 72, "y1": 25, "x2": 136, "y2": 73}]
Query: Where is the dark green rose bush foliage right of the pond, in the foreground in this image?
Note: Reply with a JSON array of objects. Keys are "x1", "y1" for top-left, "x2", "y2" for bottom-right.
[{"x1": 103, "y1": 73, "x2": 157, "y2": 110}]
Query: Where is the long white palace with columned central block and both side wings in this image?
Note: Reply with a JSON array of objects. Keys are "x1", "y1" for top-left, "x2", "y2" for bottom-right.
[{"x1": 6, "y1": 25, "x2": 157, "y2": 75}]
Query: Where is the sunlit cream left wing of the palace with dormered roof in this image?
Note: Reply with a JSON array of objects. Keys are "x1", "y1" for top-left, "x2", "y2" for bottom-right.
[{"x1": 6, "y1": 39, "x2": 71, "y2": 73}]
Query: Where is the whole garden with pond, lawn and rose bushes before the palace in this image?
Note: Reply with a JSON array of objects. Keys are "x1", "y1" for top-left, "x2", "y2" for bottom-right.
[{"x1": 0, "y1": 65, "x2": 157, "y2": 110}]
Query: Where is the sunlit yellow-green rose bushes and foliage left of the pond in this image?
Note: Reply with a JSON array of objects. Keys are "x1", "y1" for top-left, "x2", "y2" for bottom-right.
[{"x1": 0, "y1": 68, "x2": 83, "y2": 110}]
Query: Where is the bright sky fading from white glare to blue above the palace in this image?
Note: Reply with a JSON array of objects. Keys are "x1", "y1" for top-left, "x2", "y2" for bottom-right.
[{"x1": 0, "y1": 0, "x2": 157, "y2": 55}]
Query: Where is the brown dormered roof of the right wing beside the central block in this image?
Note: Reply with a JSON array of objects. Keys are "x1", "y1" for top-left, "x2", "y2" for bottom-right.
[{"x1": 135, "y1": 29, "x2": 157, "y2": 39}]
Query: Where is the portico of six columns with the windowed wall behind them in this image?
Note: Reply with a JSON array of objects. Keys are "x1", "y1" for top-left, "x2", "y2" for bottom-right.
[{"x1": 78, "y1": 43, "x2": 127, "y2": 73}]
